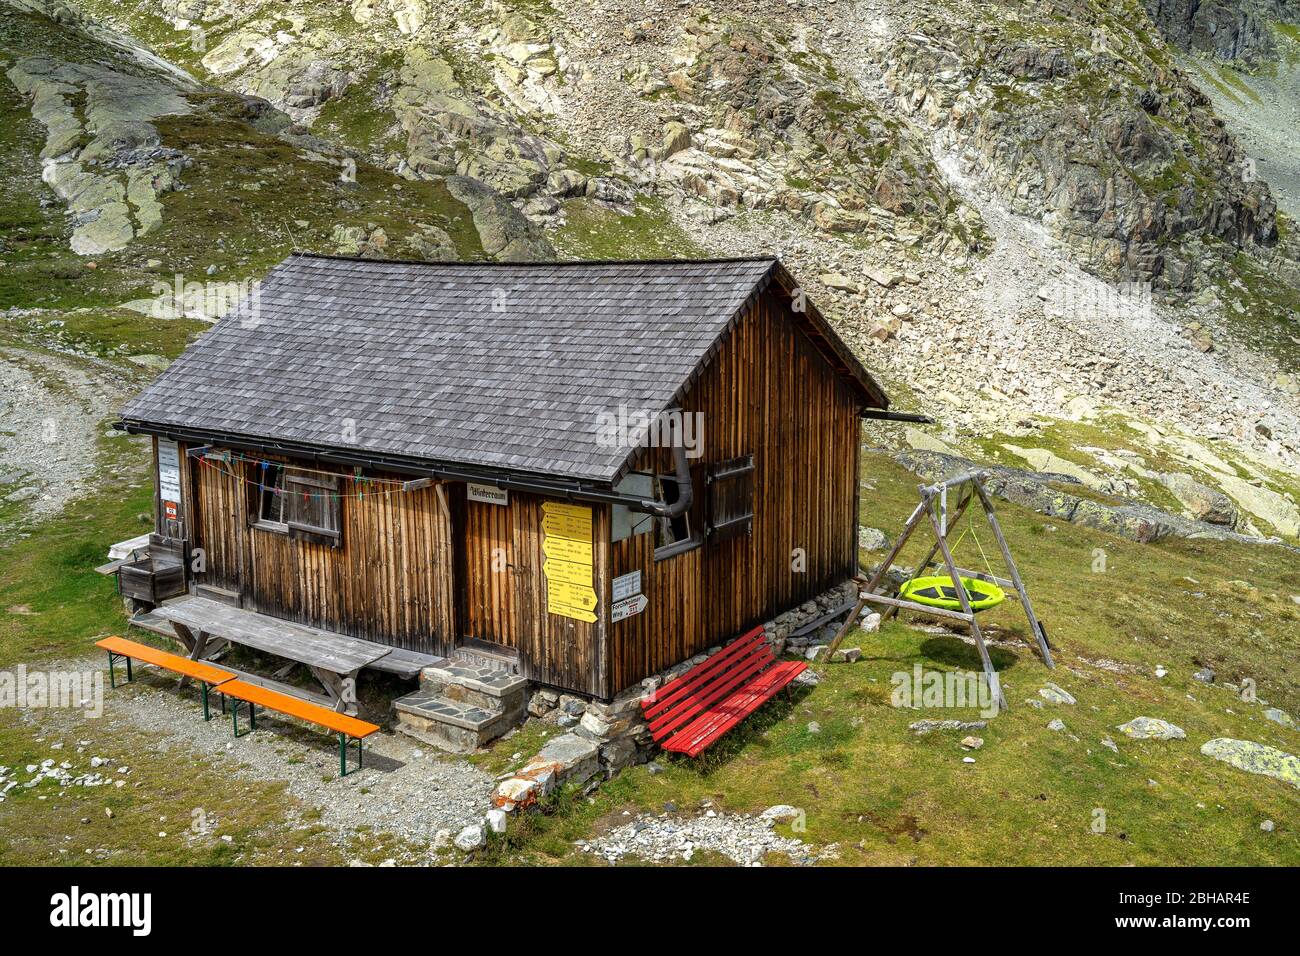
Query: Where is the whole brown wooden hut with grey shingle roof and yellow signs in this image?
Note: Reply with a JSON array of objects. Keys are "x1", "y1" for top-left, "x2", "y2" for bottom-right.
[{"x1": 118, "y1": 254, "x2": 888, "y2": 698}]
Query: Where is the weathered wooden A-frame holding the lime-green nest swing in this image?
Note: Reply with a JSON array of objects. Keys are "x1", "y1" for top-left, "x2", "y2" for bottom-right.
[{"x1": 826, "y1": 471, "x2": 1056, "y2": 710}]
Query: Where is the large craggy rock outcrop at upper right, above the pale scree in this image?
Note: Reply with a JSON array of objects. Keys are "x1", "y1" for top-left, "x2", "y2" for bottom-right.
[{"x1": 887, "y1": 22, "x2": 1278, "y2": 289}]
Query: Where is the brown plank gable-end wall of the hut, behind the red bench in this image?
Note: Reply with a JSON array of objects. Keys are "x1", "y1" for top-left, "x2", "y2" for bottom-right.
[{"x1": 598, "y1": 293, "x2": 861, "y2": 696}]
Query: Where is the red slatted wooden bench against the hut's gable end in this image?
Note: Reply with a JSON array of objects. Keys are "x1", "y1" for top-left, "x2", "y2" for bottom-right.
[{"x1": 641, "y1": 627, "x2": 807, "y2": 757}]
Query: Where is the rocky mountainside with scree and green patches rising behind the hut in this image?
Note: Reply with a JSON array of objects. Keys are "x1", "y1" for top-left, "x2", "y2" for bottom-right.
[{"x1": 0, "y1": 0, "x2": 1300, "y2": 546}]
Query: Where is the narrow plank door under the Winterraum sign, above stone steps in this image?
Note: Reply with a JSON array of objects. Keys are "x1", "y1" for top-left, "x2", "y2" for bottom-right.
[{"x1": 465, "y1": 501, "x2": 528, "y2": 649}]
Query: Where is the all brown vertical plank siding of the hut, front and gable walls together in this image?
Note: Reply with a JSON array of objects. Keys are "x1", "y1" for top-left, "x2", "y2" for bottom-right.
[{"x1": 155, "y1": 287, "x2": 862, "y2": 698}]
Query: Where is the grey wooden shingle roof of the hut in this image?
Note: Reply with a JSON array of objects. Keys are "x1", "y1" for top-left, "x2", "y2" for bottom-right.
[{"x1": 122, "y1": 254, "x2": 879, "y2": 483}]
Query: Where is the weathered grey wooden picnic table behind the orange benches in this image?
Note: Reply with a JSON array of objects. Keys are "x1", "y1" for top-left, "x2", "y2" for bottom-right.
[{"x1": 153, "y1": 597, "x2": 391, "y2": 715}]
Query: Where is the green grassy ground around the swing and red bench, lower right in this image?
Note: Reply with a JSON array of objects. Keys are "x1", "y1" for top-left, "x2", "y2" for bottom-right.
[{"x1": 484, "y1": 457, "x2": 1300, "y2": 865}]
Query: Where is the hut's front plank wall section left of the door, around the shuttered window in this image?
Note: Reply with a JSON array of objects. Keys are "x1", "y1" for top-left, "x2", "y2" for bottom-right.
[{"x1": 172, "y1": 444, "x2": 456, "y2": 654}]
